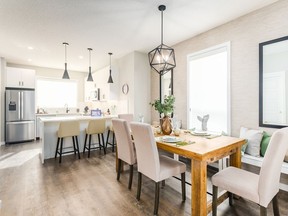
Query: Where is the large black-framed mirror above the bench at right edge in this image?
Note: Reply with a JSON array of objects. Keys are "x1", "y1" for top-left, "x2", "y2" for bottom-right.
[{"x1": 259, "y1": 36, "x2": 288, "y2": 128}]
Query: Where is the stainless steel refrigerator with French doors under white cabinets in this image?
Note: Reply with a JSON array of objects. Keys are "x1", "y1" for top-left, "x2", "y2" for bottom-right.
[{"x1": 5, "y1": 88, "x2": 35, "y2": 144}]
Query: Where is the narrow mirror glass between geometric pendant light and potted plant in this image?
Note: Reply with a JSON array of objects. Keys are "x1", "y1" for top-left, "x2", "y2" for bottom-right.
[{"x1": 159, "y1": 69, "x2": 173, "y2": 102}]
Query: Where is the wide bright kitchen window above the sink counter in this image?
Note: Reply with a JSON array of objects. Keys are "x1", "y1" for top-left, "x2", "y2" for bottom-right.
[{"x1": 36, "y1": 78, "x2": 78, "y2": 108}]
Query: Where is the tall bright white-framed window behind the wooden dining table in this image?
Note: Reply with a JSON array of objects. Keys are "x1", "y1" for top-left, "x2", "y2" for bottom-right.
[{"x1": 187, "y1": 43, "x2": 230, "y2": 134}]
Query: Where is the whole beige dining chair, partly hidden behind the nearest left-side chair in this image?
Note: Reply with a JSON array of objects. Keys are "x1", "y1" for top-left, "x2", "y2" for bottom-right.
[{"x1": 112, "y1": 119, "x2": 137, "y2": 190}]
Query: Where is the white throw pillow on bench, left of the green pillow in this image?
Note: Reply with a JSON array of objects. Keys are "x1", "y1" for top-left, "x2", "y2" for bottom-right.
[{"x1": 240, "y1": 127, "x2": 263, "y2": 157}]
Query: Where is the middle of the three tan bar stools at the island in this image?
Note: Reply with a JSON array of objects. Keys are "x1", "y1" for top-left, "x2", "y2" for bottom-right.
[{"x1": 83, "y1": 119, "x2": 106, "y2": 158}]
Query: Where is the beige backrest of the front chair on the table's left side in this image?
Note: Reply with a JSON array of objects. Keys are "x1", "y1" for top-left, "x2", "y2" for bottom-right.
[{"x1": 130, "y1": 122, "x2": 160, "y2": 182}]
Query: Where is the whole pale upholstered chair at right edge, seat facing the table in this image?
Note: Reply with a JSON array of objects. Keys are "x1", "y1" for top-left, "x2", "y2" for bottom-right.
[{"x1": 212, "y1": 128, "x2": 288, "y2": 216}]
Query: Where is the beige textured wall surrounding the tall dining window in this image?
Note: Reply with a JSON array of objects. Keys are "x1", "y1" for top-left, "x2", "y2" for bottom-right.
[{"x1": 151, "y1": 0, "x2": 288, "y2": 136}]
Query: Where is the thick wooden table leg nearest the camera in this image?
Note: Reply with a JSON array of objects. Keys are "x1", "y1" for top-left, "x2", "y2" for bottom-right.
[{"x1": 191, "y1": 159, "x2": 207, "y2": 216}]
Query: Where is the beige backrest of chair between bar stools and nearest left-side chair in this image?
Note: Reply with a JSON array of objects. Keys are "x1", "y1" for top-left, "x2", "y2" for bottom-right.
[{"x1": 112, "y1": 119, "x2": 136, "y2": 165}]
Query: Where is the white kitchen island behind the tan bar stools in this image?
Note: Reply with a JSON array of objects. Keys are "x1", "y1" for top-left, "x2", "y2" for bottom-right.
[{"x1": 39, "y1": 115, "x2": 117, "y2": 163}]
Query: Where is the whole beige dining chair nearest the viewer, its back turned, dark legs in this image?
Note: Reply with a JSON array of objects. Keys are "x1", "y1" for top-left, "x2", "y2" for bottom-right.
[{"x1": 130, "y1": 122, "x2": 186, "y2": 215}]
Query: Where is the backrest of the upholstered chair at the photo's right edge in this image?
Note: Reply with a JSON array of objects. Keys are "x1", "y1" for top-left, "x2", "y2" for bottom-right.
[{"x1": 258, "y1": 127, "x2": 288, "y2": 206}]
